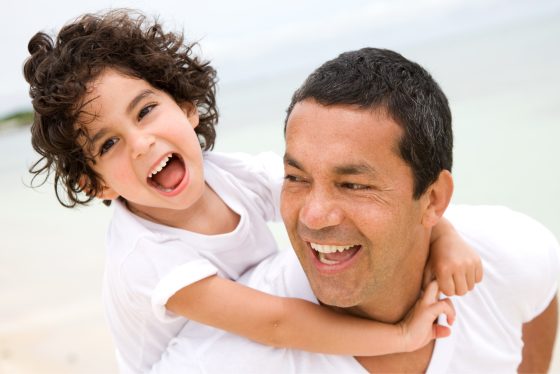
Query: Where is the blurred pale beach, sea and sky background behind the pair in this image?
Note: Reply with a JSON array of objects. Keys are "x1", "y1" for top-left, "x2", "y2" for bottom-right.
[{"x1": 0, "y1": 0, "x2": 560, "y2": 374}]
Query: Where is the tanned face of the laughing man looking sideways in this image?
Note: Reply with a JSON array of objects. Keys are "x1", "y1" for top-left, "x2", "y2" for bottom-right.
[{"x1": 281, "y1": 100, "x2": 429, "y2": 311}]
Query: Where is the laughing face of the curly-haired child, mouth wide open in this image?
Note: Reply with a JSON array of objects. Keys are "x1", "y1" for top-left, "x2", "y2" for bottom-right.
[{"x1": 82, "y1": 69, "x2": 205, "y2": 220}]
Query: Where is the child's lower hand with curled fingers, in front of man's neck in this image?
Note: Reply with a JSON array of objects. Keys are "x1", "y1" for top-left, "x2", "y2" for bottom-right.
[{"x1": 400, "y1": 281, "x2": 455, "y2": 352}]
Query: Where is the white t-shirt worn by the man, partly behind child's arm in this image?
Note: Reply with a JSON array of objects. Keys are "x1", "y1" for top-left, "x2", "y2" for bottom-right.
[{"x1": 153, "y1": 206, "x2": 560, "y2": 374}]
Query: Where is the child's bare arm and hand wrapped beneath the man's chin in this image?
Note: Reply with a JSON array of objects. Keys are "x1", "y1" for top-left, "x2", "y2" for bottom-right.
[{"x1": 166, "y1": 276, "x2": 454, "y2": 356}]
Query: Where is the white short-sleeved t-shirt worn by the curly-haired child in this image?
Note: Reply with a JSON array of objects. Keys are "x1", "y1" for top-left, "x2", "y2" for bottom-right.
[{"x1": 103, "y1": 152, "x2": 284, "y2": 373}]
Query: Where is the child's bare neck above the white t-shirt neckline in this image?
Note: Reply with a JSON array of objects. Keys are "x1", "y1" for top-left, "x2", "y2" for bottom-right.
[{"x1": 126, "y1": 184, "x2": 240, "y2": 235}]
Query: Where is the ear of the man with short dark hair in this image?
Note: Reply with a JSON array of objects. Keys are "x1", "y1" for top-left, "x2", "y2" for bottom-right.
[{"x1": 422, "y1": 170, "x2": 453, "y2": 227}]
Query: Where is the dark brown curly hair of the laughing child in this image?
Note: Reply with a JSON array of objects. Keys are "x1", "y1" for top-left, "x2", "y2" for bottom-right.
[{"x1": 23, "y1": 9, "x2": 218, "y2": 208}]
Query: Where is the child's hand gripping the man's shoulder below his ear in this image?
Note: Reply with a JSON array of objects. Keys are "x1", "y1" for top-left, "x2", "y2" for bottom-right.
[{"x1": 424, "y1": 218, "x2": 482, "y2": 296}]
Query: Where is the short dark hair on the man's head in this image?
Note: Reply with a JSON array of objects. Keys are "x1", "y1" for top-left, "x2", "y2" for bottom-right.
[{"x1": 286, "y1": 48, "x2": 453, "y2": 198}]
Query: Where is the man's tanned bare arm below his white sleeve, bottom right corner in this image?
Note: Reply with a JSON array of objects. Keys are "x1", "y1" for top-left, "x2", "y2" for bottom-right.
[{"x1": 517, "y1": 296, "x2": 558, "y2": 373}]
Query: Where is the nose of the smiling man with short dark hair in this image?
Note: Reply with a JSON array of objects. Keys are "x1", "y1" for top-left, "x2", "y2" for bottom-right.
[{"x1": 299, "y1": 190, "x2": 344, "y2": 230}]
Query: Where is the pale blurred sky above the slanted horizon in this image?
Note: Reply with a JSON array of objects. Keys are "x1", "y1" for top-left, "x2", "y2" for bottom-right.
[{"x1": 0, "y1": 0, "x2": 560, "y2": 116}]
